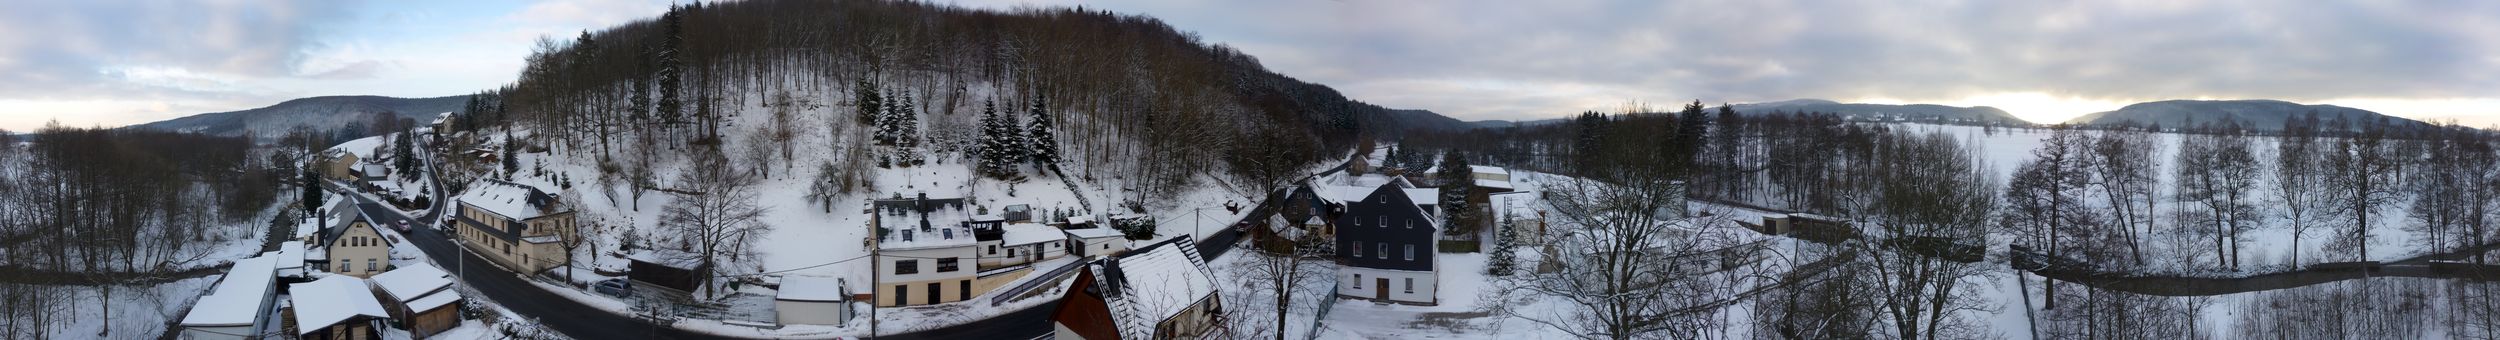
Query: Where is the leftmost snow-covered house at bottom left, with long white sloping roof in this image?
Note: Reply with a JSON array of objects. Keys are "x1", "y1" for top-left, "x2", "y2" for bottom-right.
[{"x1": 183, "y1": 255, "x2": 278, "y2": 340}]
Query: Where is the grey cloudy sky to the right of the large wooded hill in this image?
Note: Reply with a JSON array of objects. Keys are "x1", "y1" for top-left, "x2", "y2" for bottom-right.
[{"x1": 968, "y1": 0, "x2": 2500, "y2": 120}]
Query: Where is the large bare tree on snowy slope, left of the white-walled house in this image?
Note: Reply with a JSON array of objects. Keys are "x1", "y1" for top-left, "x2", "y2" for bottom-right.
[{"x1": 663, "y1": 153, "x2": 773, "y2": 295}]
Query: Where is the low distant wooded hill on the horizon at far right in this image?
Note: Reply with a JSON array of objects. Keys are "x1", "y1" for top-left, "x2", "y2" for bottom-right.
[{"x1": 2068, "y1": 100, "x2": 2430, "y2": 130}]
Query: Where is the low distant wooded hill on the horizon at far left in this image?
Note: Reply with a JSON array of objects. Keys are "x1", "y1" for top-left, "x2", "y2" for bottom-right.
[{"x1": 133, "y1": 95, "x2": 468, "y2": 140}]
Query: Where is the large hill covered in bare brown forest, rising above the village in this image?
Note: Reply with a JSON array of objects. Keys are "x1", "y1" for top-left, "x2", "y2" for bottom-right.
[{"x1": 463, "y1": 0, "x2": 1450, "y2": 180}]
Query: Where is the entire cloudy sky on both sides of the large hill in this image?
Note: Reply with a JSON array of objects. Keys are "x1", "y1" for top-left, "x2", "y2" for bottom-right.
[{"x1": 0, "y1": 0, "x2": 2500, "y2": 130}]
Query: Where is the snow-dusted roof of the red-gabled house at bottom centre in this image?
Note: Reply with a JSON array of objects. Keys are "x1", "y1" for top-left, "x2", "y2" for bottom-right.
[{"x1": 1108, "y1": 235, "x2": 1215, "y2": 340}]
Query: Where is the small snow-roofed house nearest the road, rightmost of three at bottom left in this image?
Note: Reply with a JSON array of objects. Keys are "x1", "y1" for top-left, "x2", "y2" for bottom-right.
[{"x1": 373, "y1": 263, "x2": 460, "y2": 340}]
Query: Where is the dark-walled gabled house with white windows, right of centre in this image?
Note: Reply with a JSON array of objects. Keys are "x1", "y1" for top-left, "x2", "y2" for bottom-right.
[{"x1": 1335, "y1": 183, "x2": 1440, "y2": 305}]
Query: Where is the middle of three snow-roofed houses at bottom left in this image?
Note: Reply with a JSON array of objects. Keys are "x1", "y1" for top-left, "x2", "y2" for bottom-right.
[{"x1": 288, "y1": 275, "x2": 390, "y2": 340}]
